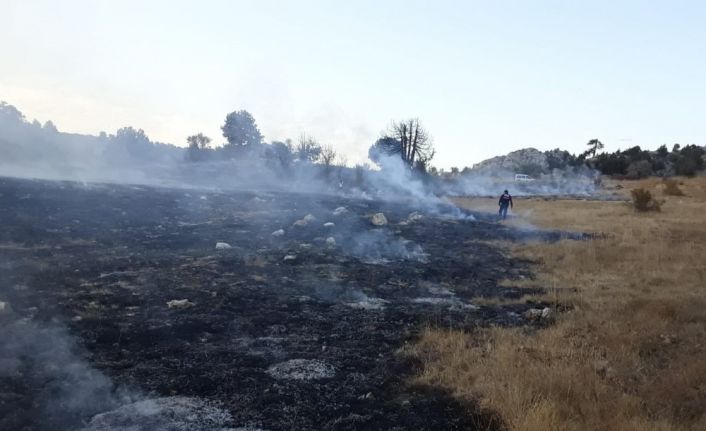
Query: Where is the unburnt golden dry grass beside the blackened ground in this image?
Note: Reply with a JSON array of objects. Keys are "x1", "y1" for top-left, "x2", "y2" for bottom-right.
[{"x1": 410, "y1": 178, "x2": 706, "y2": 431}]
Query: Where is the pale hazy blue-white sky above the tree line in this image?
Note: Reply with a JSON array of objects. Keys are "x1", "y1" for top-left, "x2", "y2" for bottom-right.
[{"x1": 0, "y1": 0, "x2": 706, "y2": 168}]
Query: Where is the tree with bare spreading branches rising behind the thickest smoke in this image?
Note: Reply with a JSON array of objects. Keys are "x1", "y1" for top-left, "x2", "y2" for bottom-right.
[{"x1": 368, "y1": 118, "x2": 434, "y2": 168}]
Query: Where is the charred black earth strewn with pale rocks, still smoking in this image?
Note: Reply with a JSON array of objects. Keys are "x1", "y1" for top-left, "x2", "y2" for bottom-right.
[{"x1": 0, "y1": 178, "x2": 560, "y2": 430}]
